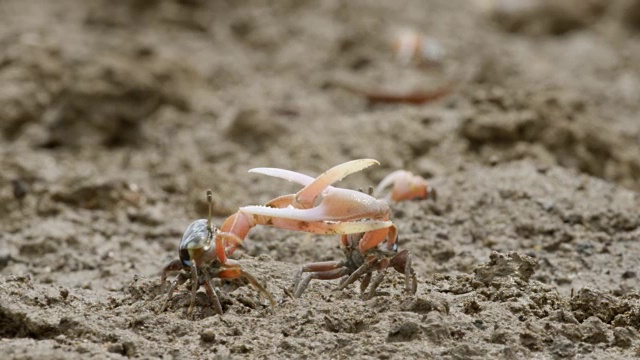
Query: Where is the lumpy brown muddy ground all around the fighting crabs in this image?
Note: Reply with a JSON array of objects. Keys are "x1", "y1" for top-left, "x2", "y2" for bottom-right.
[{"x1": 0, "y1": 0, "x2": 640, "y2": 359}]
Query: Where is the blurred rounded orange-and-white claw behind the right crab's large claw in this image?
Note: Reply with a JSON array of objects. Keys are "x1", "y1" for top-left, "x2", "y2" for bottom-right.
[{"x1": 373, "y1": 170, "x2": 432, "y2": 202}]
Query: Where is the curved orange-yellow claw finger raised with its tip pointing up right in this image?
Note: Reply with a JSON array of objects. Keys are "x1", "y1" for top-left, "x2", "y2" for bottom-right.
[{"x1": 293, "y1": 159, "x2": 379, "y2": 209}]
